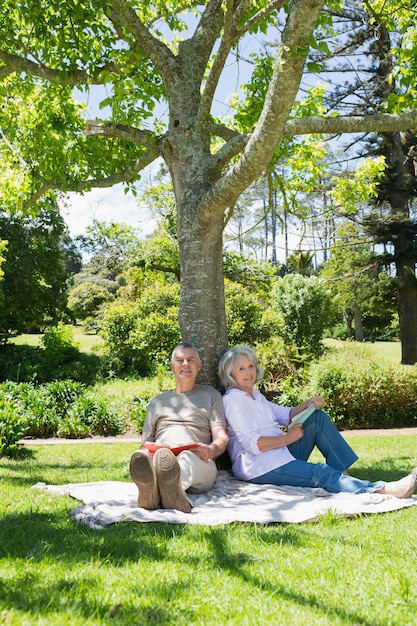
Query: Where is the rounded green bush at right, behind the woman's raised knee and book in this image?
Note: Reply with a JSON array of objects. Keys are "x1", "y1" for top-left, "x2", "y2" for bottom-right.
[{"x1": 279, "y1": 344, "x2": 417, "y2": 429}]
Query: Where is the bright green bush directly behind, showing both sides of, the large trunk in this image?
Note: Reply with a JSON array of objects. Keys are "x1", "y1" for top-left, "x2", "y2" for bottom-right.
[{"x1": 99, "y1": 280, "x2": 278, "y2": 377}]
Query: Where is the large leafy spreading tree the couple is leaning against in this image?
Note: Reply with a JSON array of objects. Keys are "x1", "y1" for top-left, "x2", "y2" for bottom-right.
[{"x1": 0, "y1": 0, "x2": 417, "y2": 380}]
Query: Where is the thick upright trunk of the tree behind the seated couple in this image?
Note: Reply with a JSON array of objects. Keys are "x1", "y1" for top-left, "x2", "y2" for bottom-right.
[{"x1": 164, "y1": 115, "x2": 227, "y2": 386}]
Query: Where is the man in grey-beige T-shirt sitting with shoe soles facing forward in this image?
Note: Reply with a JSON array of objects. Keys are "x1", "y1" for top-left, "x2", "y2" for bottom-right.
[{"x1": 130, "y1": 343, "x2": 228, "y2": 513}]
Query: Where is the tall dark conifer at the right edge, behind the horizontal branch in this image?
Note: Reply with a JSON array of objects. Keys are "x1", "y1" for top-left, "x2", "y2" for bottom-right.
[{"x1": 317, "y1": 0, "x2": 417, "y2": 364}]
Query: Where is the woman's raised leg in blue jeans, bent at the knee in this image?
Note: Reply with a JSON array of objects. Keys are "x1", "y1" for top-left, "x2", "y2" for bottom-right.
[{"x1": 288, "y1": 411, "x2": 358, "y2": 471}]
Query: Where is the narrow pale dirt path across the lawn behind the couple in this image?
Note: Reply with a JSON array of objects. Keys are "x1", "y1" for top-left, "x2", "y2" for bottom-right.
[{"x1": 19, "y1": 427, "x2": 417, "y2": 446}]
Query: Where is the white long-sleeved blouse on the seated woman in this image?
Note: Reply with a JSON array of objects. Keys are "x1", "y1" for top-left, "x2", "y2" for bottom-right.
[{"x1": 223, "y1": 388, "x2": 295, "y2": 480}]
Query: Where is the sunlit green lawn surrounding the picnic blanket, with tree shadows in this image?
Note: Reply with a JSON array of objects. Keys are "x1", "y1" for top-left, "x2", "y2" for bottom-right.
[{"x1": 0, "y1": 434, "x2": 417, "y2": 626}]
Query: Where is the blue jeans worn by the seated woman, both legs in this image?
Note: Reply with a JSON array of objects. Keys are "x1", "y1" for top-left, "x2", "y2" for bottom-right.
[{"x1": 250, "y1": 411, "x2": 385, "y2": 493}]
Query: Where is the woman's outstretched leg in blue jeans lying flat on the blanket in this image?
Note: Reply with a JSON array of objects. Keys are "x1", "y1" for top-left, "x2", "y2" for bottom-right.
[{"x1": 250, "y1": 460, "x2": 386, "y2": 493}]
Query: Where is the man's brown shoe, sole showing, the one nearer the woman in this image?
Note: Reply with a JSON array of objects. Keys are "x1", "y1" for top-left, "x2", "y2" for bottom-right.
[{"x1": 153, "y1": 448, "x2": 192, "y2": 513}]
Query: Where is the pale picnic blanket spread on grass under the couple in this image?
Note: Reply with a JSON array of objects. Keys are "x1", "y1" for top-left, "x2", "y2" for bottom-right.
[{"x1": 33, "y1": 470, "x2": 417, "y2": 528}]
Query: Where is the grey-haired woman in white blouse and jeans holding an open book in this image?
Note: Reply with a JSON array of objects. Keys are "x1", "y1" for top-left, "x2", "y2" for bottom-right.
[{"x1": 219, "y1": 346, "x2": 417, "y2": 498}]
